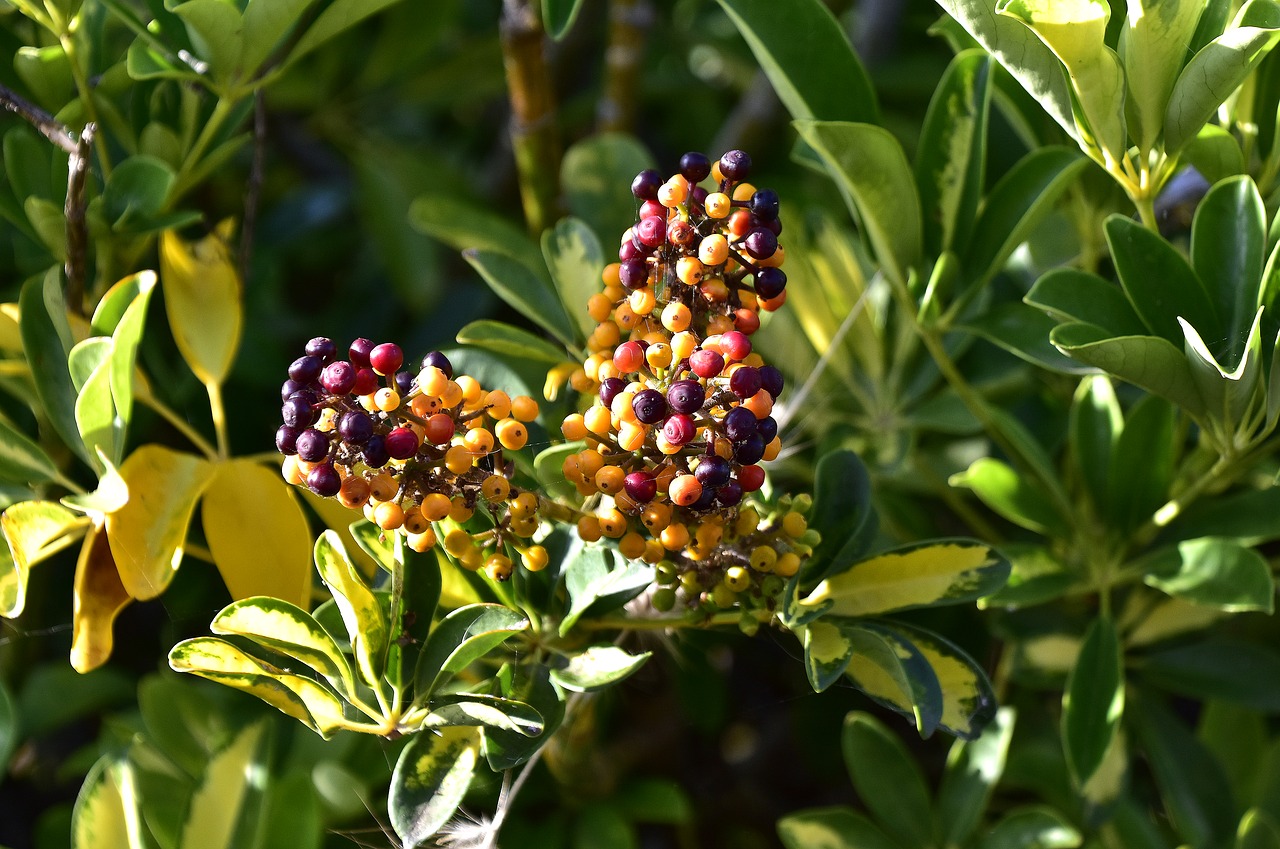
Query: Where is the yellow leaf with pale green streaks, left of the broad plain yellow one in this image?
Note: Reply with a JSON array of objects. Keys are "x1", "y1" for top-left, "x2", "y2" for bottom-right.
[{"x1": 106, "y1": 444, "x2": 214, "y2": 601}]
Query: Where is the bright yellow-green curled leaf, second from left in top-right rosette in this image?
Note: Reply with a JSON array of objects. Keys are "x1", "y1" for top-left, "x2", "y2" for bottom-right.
[{"x1": 996, "y1": 0, "x2": 1128, "y2": 160}]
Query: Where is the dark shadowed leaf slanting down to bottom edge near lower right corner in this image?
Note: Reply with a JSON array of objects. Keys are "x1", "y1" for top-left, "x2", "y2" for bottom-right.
[{"x1": 1128, "y1": 697, "x2": 1236, "y2": 846}]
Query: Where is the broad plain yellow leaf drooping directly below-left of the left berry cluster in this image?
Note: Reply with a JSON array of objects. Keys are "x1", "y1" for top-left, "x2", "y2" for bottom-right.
[{"x1": 201, "y1": 460, "x2": 311, "y2": 607}]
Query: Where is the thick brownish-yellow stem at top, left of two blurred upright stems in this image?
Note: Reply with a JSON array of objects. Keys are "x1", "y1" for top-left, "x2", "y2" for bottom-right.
[{"x1": 499, "y1": 0, "x2": 559, "y2": 234}]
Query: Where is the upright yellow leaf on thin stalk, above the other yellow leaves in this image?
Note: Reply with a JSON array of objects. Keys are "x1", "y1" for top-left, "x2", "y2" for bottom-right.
[{"x1": 160, "y1": 228, "x2": 243, "y2": 385}]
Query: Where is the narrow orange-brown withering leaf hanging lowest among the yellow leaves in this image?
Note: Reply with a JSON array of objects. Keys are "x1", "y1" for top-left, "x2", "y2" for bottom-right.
[{"x1": 72, "y1": 524, "x2": 133, "y2": 672}]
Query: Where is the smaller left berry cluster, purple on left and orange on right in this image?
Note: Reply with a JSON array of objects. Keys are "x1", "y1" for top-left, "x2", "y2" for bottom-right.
[{"x1": 275, "y1": 337, "x2": 548, "y2": 580}]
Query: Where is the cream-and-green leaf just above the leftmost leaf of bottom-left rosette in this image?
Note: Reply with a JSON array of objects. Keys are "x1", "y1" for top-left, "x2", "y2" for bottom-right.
[{"x1": 209, "y1": 597, "x2": 355, "y2": 693}]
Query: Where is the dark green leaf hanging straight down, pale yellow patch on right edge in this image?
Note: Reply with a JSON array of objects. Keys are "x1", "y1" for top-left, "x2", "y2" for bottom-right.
[{"x1": 1061, "y1": 616, "x2": 1124, "y2": 788}]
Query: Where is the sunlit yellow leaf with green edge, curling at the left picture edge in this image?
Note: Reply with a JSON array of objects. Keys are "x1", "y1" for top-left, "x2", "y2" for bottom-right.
[{"x1": 0, "y1": 501, "x2": 90, "y2": 619}]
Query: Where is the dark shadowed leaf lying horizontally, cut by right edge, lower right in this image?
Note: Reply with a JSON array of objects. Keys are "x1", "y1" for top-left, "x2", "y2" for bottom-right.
[{"x1": 1137, "y1": 636, "x2": 1280, "y2": 713}]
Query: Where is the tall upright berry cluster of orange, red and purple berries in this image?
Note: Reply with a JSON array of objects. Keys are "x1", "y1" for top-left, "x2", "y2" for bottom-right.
[{"x1": 562, "y1": 150, "x2": 808, "y2": 606}]
